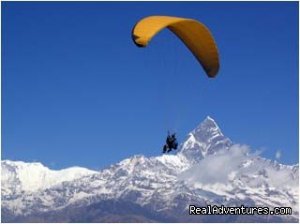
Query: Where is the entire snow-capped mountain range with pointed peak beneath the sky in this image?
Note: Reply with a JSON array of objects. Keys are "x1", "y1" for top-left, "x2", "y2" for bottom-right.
[{"x1": 1, "y1": 117, "x2": 299, "y2": 222}]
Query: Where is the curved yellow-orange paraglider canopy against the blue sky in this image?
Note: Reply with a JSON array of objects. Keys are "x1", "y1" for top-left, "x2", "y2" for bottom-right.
[{"x1": 132, "y1": 16, "x2": 220, "y2": 77}]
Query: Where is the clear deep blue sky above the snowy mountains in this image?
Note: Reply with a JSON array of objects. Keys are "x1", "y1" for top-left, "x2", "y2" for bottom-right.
[{"x1": 1, "y1": 2, "x2": 299, "y2": 169}]
